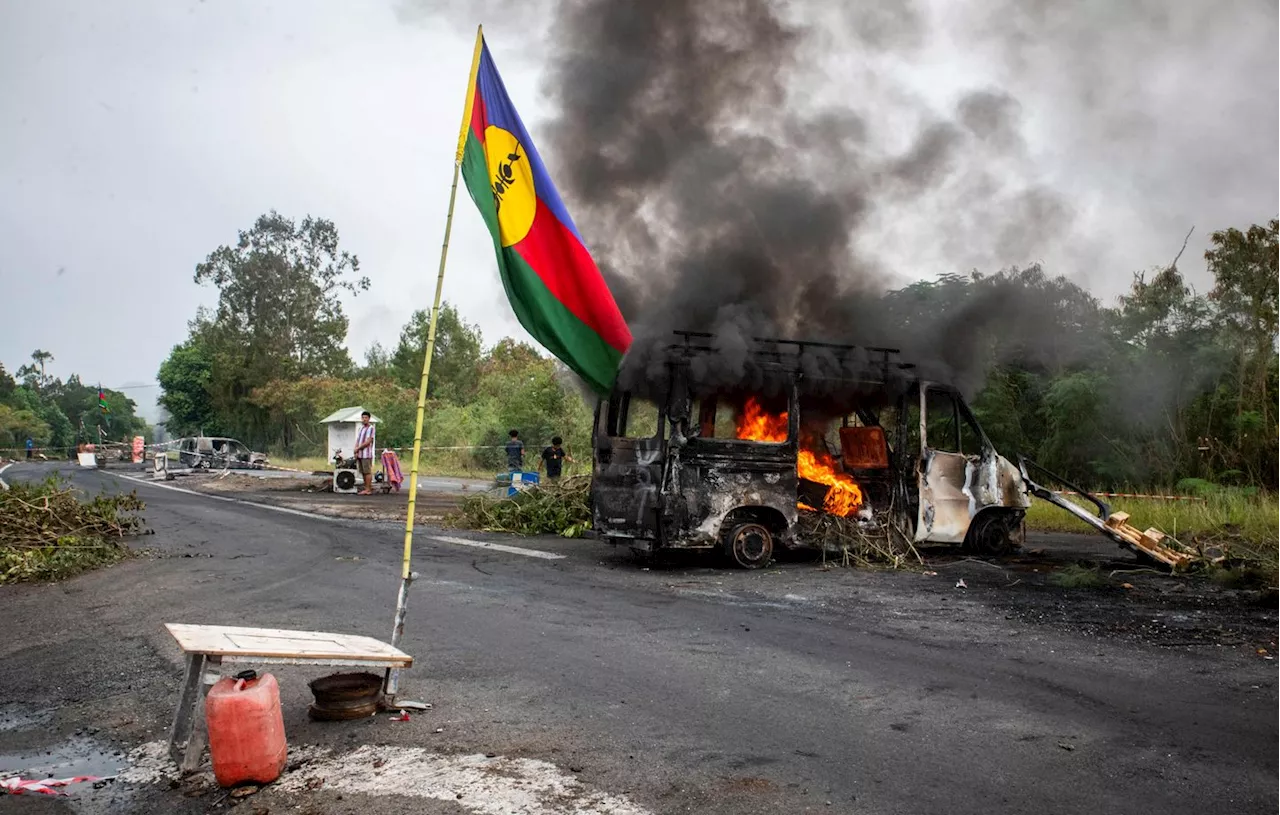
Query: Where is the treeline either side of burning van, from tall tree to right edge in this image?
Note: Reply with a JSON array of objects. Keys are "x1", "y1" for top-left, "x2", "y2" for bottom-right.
[{"x1": 159, "y1": 212, "x2": 1280, "y2": 487}]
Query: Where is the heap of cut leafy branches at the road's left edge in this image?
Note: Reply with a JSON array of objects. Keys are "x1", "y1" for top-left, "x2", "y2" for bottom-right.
[{"x1": 0, "y1": 479, "x2": 143, "y2": 583}]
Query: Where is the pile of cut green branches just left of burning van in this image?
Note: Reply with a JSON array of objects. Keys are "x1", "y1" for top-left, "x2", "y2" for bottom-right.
[{"x1": 452, "y1": 479, "x2": 591, "y2": 537}]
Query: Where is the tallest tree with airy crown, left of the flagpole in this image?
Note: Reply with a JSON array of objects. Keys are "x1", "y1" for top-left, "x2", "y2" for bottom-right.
[{"x1": 192, "y1": 211, "x2": 369, "y2": 438}]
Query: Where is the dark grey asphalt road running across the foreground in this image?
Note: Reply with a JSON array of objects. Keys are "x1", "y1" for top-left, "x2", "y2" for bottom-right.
[{"x1": 0, "y1": 464, "x2": 1280, "y2": 815}]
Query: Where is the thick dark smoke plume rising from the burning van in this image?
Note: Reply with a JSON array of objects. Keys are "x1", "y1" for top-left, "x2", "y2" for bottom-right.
[{"x1": 524, "y1": 0, "x2": 1085, "y2": 396}]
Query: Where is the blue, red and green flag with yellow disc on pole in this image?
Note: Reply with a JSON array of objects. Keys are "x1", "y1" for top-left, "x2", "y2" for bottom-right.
[{"x1": 458, "y1": 32, "x2": 631, "y2": 394}]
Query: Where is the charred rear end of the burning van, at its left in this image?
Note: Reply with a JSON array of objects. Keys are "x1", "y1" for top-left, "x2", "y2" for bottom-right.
[{"x1": 591, "y1": 392, "x2": 666, "y2": 549}]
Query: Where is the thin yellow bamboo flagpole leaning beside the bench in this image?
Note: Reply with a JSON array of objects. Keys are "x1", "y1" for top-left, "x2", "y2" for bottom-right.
[{"x1": 383, "y1": 26, "x2": 484, "y2": 704}]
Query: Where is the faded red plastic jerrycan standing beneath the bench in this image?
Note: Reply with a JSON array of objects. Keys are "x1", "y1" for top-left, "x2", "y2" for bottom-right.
[{"x1": 205, "y1": 670, "x2": 288, "y2": 787}]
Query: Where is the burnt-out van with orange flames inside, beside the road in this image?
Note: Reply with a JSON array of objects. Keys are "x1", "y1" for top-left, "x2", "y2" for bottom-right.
[{"x1": 591, "y1": 331, "x2": 1030, "y2": 568}]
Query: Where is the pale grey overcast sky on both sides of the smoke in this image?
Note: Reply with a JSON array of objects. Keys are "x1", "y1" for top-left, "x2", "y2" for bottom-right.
[{"x1": 0, "y1": 0, "x2": 1280, "y2": 419}]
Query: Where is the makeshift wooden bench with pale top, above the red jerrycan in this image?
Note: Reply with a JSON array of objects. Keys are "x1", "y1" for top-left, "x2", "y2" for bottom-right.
[{"x1": 165, "y1": 623, "x2": 413, "y2": 773}]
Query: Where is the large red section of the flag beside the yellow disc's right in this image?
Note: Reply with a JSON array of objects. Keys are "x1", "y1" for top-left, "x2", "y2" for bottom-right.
[{"x1": 512, "y1": 198, "x2": 631, "y2": 353}]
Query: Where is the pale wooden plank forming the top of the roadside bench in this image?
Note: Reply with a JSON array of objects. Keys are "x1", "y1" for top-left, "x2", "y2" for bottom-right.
[{"x1": 165, "y1": 623, "x2": 413, "y2": 667}]
